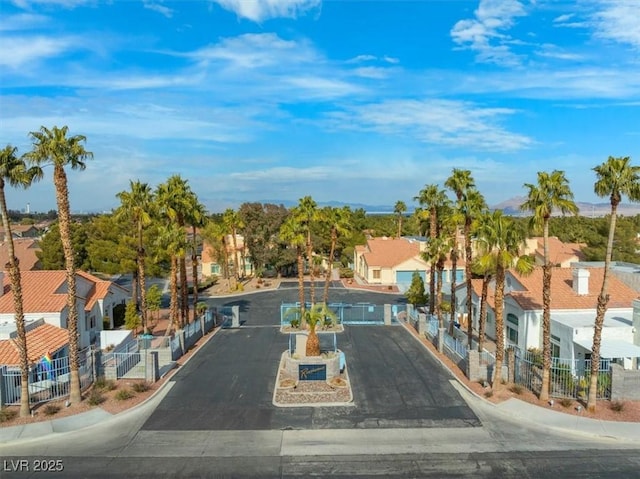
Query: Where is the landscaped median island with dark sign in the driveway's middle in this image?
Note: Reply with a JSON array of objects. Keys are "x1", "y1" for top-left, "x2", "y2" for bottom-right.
[{"x1": 273, "y1": 351, "x2": 353, "y2": 407}]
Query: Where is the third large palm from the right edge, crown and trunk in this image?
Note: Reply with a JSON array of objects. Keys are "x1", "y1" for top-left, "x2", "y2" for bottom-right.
[{"x1": 476, "y1": 210, "x2": 534, "y2": 389}]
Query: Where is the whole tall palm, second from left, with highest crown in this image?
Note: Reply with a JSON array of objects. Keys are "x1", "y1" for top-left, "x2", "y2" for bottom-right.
[{"x1": 25, "y1": 126, "x2": 93, "y2": 404}]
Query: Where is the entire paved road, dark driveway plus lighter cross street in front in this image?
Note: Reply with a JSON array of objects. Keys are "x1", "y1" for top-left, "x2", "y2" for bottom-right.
[{"x1": 0, "y1": 288, "x2": 640, "y2": 479}]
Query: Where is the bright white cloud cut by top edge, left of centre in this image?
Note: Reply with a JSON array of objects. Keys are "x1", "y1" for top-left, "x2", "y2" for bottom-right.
[{"x1": 214, "y1": 0, "x2": 321, "y2": 22}]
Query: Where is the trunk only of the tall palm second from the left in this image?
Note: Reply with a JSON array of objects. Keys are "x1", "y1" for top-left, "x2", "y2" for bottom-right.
[{"x1": 53, "y1": 164, "x2": 82, "y2": 404}]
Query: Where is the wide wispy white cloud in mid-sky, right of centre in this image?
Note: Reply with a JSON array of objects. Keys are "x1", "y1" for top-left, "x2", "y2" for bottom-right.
[{"x1": 329, "y1": 99, "x2": 533, "y2": 151}]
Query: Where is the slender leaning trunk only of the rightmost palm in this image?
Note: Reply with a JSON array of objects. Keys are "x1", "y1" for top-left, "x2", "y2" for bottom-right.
[{"x1": 587, "y1": 199, "x2": 618, "y2": 412}]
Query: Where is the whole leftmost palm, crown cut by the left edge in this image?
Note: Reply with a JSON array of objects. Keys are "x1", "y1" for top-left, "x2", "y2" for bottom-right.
[{"x1": 0, "y1": 145, "x2": 42, "y2": 417}]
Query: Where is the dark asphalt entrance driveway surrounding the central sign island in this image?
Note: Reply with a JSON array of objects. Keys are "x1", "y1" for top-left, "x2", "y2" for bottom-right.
[{"x1": 143, "y1": 289, "x2": 480, "y2": 431}]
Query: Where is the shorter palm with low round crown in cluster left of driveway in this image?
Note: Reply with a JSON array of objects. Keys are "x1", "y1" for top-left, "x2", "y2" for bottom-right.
[{"x1": 156, "y1": 223, "x2": 187, "y2": 336}]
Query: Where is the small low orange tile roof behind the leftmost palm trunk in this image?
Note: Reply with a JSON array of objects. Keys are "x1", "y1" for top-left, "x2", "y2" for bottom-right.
[{"x1": 0, "y1": 323, "x2": 69, "y2": 366}]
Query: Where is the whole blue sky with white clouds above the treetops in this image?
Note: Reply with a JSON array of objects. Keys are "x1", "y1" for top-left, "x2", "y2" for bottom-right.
[{"x1": 0, "y1": 0, "x2": 640, "y2": 212}]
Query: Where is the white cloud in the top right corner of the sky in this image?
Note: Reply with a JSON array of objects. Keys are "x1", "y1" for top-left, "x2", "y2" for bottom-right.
[{"x1": 592, "y1": 0, "x2": 640, "y2": 49}]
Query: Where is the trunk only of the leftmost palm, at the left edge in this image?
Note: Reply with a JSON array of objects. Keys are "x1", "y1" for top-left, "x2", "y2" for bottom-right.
[{"x1": 0, "y1": 186, "x2": 31, "y2": 417}]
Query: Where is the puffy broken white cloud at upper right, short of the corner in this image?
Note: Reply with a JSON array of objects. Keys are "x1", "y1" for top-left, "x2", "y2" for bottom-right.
[{"x1": 451, "y1": 0, "x2": 527, "y2": 64}]
